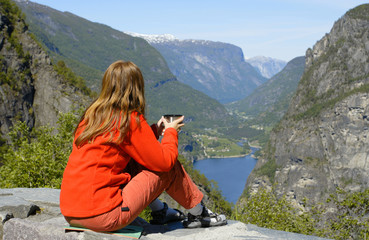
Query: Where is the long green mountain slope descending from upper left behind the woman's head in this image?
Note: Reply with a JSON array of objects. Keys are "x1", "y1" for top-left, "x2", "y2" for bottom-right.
[{"x1": 17, "y1": 0, "x2": 233, "y2": 128}]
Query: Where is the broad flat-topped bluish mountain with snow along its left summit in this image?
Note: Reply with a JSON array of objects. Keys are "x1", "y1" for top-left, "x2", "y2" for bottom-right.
[{"x1": 130, "y1": 33, "x2": 266, "y2": 103}]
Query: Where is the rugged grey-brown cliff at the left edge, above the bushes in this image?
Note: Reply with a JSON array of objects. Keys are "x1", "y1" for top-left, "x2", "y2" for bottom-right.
[{"x1": 0, "y1": 1, "x2": 89, "y2": 141}]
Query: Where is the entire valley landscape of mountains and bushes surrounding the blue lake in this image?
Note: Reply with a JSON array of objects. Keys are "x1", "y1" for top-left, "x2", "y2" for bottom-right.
[{"x1": 0, "y1": 0, "x2": 369, "y2": 239}]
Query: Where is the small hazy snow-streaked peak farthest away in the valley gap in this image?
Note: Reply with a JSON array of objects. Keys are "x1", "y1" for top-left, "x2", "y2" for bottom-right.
[{"x1": 246, "y1": 56, "x2": 287, "y2": 78}]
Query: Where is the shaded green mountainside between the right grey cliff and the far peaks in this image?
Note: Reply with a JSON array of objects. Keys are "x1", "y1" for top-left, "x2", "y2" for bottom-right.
[{"x1": 227, "y1": 57, "x2": 305, "y2": 126}]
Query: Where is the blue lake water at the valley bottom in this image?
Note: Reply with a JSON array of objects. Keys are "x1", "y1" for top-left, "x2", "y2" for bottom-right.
[{"x1": 194, "y1": 148, "x2": 257, "y2": 203}]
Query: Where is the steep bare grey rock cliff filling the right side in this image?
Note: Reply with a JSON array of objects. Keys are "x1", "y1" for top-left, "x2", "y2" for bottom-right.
[{"x1": 247, "y1": 4, "x2": 369, "y2": 206}]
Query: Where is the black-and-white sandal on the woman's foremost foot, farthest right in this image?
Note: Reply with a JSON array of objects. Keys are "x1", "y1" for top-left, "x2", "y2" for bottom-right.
[{"x1": 183, "y1": 206, "x2": 227, "y2": 228}]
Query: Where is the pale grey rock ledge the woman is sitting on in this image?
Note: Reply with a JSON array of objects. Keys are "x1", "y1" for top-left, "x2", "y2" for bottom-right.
[{"x1": 0, "y1": 188, "x2": 328, "y2": 240}]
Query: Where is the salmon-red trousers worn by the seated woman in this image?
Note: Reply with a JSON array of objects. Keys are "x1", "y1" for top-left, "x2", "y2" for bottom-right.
[{"x1": 65, "y1": 161, "x2": 203, "y2": 231}]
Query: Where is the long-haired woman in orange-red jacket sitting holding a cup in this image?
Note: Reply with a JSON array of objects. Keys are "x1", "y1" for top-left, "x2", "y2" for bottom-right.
[{"x1": 60, "y1": 61, "x2": 226, "y2": 231}]
